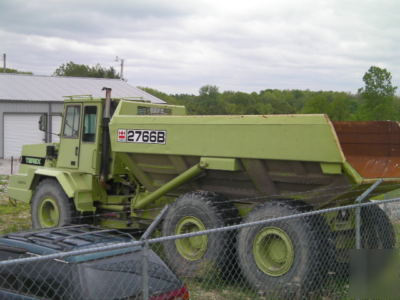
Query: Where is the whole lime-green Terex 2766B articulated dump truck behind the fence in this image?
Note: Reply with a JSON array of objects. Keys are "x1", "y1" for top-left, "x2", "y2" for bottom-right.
[{"x1": 8, "y1": 89, "x2": 400, "y2": 289}]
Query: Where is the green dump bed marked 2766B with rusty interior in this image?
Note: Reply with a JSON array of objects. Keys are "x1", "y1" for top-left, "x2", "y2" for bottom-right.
[{"x1": 110, "y1": 101, "x2": 400, "y2": 205}]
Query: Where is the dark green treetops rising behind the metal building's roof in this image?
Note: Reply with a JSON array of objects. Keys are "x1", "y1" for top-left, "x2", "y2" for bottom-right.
[{"x1": 54, "y1": 61, "x2": 120, "y2": 78}]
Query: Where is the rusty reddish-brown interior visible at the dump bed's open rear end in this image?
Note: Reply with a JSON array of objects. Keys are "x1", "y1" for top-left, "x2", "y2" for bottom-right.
[{"x1": 333, "y1": 121, "x2": 400, "y2": 178}]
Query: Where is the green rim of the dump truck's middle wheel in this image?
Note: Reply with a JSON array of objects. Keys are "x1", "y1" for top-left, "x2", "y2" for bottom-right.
[{"x1": 175, "y1": 217, "x2": 208, "y2": 261}]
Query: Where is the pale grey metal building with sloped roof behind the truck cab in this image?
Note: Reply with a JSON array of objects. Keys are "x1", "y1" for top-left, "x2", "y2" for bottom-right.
[{"x1": 0, "y1": 73, "x2": 164, "y2": 158}]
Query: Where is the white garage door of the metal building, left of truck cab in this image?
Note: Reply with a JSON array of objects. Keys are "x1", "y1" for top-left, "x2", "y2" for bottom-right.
[{"x1": 4, "y1": 114, "x2": 45, "y2": 158}]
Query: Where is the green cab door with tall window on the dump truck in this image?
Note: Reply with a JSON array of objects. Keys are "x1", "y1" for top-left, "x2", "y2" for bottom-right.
[{"x1": 57, "y1": 103, "x2": 82, "y2": 169}]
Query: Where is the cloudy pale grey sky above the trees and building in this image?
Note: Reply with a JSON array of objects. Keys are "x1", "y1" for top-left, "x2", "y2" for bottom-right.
[{"x1": 0, "y1": 0, "x2": 400, "y2": 94}]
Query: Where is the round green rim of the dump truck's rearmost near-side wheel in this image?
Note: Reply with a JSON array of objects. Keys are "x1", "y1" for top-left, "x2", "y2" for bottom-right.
[{"x1": 253, "y1": 227, "x2": 294, "y2": 276}]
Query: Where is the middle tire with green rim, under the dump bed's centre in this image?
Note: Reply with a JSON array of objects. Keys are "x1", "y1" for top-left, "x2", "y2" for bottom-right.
[{"x1": 162, "y1": 192, "x2": 238, "y2": 277}]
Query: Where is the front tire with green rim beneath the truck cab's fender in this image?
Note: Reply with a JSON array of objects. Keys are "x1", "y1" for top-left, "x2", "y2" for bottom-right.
[{"x1": 31, "y1": 178, "x2": 74, "y2": 228}]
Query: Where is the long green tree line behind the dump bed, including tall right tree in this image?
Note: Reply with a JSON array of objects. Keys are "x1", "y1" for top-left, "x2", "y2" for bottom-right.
[{"x1": 142, "y1": 67, "x2": 400, "y2": 121}]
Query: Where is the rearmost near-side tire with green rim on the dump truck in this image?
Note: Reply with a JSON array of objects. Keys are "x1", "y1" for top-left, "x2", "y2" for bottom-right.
[{"x1": 237, "y1": 201, "x2": 334, "y2": 299}]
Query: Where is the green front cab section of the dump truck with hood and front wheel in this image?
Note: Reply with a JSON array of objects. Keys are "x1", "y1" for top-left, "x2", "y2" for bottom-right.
[{"x1": 8, "y1": 90, "x2": 186, "y2": 228}]
